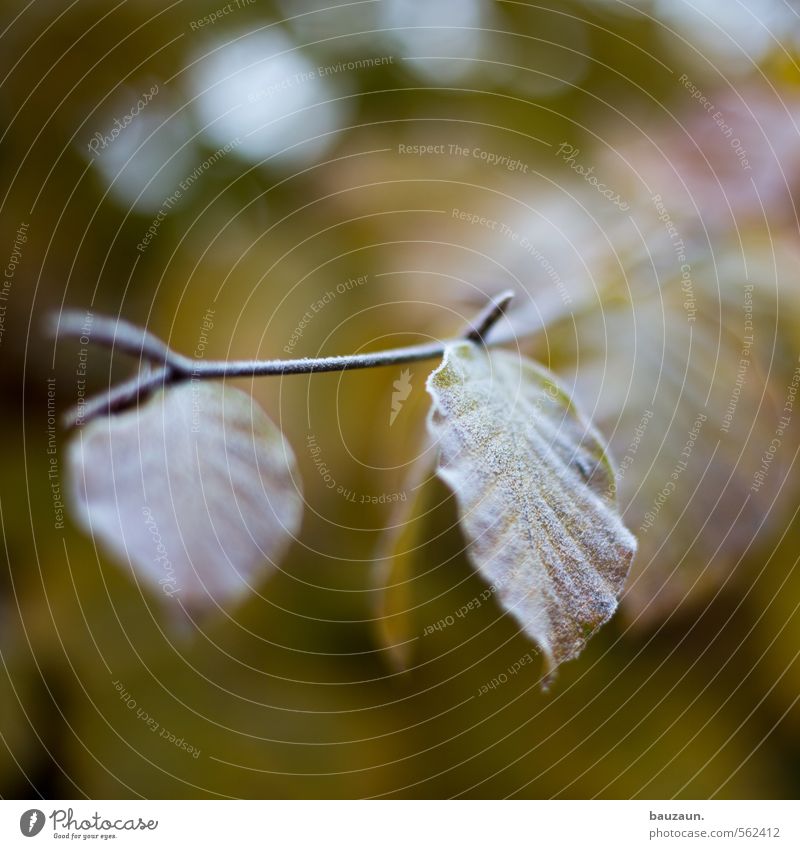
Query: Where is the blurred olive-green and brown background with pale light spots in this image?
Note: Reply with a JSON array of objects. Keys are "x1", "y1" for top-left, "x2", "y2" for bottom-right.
[{"x1": 0, "y1": 0, "x2": 800, "y2": 798}]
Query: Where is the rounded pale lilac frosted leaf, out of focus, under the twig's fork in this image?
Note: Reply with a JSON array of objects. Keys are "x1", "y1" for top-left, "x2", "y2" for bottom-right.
[{"x1": 68, "y1": 381, "x2": 302, "y2": 609}]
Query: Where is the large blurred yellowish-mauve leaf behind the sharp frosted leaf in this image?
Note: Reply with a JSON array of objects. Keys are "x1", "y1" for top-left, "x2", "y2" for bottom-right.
[{"x1": 536, "y1": 272, "x2": 794, "y2": 625}]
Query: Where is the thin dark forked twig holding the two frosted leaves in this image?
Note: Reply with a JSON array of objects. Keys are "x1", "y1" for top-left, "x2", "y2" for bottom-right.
[{"x1": 49, "y1": 291, "x2": 514, "y2": 428}]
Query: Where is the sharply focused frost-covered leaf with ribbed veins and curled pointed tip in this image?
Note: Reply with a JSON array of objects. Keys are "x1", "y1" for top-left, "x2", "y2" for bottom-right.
[{"x1": 428, "y1": 343, "x2": 636, "y2": 673}]
